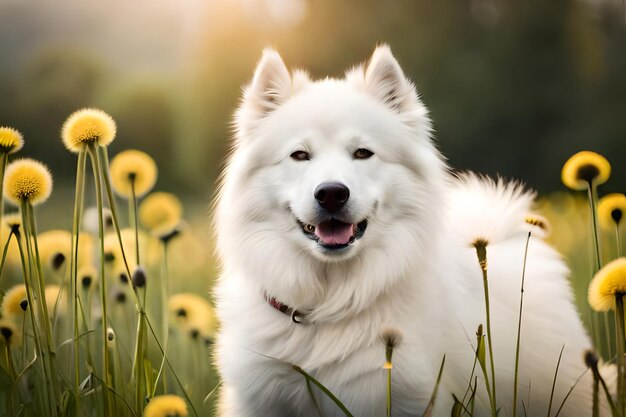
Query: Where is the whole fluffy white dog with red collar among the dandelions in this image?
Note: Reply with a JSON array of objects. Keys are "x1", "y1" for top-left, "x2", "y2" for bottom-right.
[{"x1": 215, "y1": 46, "x2": 608, "y2": 417}]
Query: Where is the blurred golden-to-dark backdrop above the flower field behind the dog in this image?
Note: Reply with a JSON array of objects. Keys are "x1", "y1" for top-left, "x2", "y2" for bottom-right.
[{"x1": 0, "y1": 0, "x2": 626, "y2": 195}]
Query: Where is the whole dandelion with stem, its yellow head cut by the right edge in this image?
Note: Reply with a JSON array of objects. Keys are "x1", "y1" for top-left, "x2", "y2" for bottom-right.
[{"x1": 588, "y1": 258, "x2": 626, "y2": 411}]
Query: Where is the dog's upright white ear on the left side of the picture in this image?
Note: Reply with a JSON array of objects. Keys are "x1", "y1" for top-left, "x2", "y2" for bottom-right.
[{"x1": 244, "y1": 48, "x2": 292, "y2": 120}]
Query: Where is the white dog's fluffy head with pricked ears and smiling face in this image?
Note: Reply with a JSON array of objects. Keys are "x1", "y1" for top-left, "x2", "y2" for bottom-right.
[{"x1": 216, "y1": 46, "x2": 444, "y2": 312}]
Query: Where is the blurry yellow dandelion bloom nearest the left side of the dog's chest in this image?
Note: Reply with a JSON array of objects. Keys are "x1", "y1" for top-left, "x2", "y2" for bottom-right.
[{"x1": 168, "y1": 293, "x2": 217, "y2": 338}]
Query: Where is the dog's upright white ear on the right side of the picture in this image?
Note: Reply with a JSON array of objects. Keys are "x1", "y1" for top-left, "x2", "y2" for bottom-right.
[{"x1": 365, "y1": 45, "x2": 417, "y2": 113}]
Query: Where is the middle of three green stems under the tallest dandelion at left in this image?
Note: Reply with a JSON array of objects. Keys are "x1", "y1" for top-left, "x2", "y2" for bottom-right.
[{"x1": 87, "y1": 144, "x2": 113, "y2": 414}]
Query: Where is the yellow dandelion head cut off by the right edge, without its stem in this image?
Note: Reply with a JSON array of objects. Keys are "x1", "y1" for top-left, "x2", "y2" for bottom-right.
[{"x1": 587, "y1": 258, "x2": 626, "y2": 311}]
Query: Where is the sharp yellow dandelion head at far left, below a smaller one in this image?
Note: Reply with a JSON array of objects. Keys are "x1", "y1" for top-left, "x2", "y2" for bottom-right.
[{"x1": 4, "y1": 158, "x2": 52, "y2": 206}]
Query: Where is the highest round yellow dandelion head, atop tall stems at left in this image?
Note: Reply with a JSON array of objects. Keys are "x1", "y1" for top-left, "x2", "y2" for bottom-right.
[{"x1": 61, "y1": 109, "x2": 117, "y2": 153}]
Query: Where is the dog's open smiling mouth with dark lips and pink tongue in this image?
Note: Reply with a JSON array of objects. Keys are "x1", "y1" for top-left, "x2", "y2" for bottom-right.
[{"x1": 298, "y1": 219, "x2": 367, "y2": 250}]
